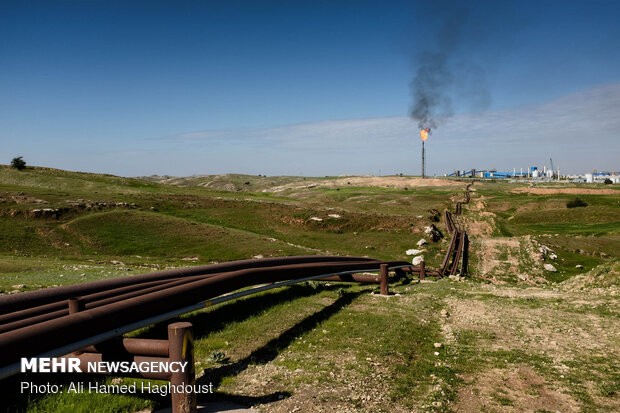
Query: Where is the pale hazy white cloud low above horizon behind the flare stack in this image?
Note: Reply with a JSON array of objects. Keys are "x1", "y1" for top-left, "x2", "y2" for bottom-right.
[{"x1": 151, "y1": 84, "x2": 620, "y2": 175}]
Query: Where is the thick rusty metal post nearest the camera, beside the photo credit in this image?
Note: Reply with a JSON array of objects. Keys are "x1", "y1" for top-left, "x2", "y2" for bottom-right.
[{"x1": 168, "y1": 322, "x2": 197, "y2": 413}]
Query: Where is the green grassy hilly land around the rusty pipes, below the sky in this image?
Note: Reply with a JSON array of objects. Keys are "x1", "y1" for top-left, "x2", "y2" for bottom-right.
[{"x1": 0, "y1": 167, "x2": 620, "y2": 412}]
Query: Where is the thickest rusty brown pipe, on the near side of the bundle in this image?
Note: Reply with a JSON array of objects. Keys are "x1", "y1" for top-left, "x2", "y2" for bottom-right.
[{"x1": 0, "y1": 257, "x2": 410, "y2": 374}]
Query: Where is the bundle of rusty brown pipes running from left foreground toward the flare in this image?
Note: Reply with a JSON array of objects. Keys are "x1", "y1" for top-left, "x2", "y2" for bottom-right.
[{"x1": 0, "y1": 184, "x2": 471, "y2": 378}]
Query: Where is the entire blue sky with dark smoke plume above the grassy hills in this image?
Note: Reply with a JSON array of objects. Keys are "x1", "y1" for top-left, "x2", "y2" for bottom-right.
[{"x1": 0, "y1": 0, "x2": 620, "y2": 176}]
